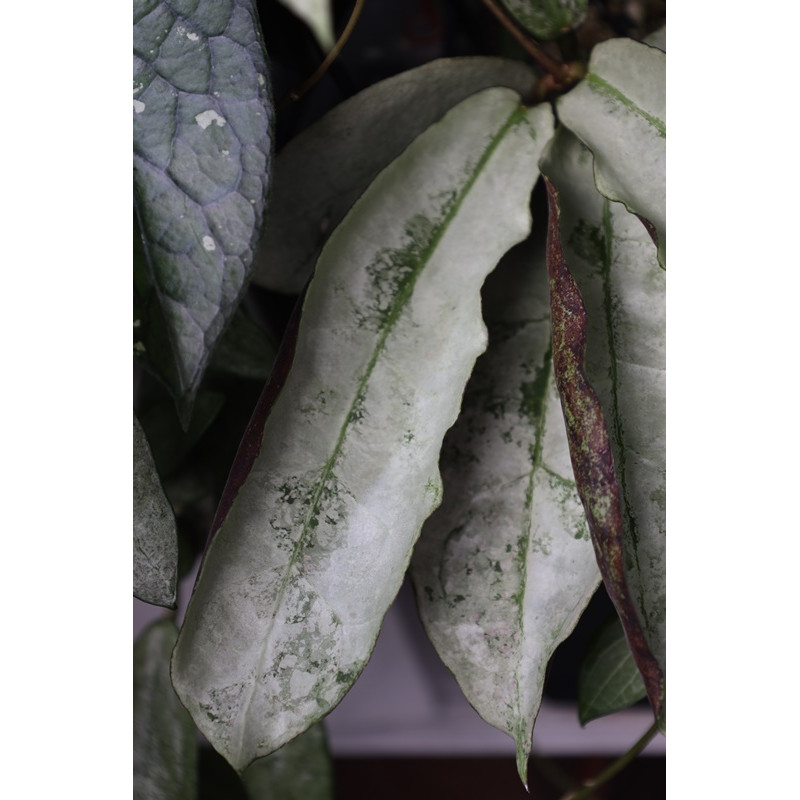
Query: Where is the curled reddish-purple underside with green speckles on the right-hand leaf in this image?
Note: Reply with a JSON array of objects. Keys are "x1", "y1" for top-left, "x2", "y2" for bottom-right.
[{"x1": 545, "y1": 179, "x2": 663, "y2": 717}]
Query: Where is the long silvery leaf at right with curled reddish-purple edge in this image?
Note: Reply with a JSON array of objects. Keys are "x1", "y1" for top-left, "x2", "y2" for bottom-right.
[{"x1": 542, "y1": 130, "x2": 666, "y2": 716}]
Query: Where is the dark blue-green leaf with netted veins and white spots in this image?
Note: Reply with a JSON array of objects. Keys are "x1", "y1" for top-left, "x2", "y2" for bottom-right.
[{"x1": 133, "y1": 0, "x2": 272, "y2": 425}]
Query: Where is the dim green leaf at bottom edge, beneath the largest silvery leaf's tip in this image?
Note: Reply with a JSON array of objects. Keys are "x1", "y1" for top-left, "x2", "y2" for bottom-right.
[{"x1": 242, "y1": 724, "x2": 333, "y2": 800}]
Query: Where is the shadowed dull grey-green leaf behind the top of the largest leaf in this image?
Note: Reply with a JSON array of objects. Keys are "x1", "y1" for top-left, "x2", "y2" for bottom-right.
[{"x1": 253, "y1": 57, "x2": 536, "y2": 294}]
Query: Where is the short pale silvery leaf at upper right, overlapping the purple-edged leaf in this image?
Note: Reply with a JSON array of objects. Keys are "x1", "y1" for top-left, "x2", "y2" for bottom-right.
[{"x1": 556, "y1": 39, "x2": 667, "y2": 267}]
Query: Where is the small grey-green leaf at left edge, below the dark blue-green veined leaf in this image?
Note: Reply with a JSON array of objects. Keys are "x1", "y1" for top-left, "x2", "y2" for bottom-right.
[{"x1": 133, "y1": 414, "x2": 178, "y2": 608}]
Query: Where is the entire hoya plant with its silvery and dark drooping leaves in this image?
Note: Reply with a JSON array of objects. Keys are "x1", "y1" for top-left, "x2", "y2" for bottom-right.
[{"x1": 133, "y1": 0, "x2": 666, "y2": 798}]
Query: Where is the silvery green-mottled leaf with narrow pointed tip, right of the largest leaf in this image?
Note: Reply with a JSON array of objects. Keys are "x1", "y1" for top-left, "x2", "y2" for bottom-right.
[{"x1": 412, "y1": 227, "x2": 600, "y2": 783}]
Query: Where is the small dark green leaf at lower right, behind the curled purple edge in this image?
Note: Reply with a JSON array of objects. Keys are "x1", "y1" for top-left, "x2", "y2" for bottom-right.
[{"x1": 578, "y1": 616, "x2": 647, "y2": 725}]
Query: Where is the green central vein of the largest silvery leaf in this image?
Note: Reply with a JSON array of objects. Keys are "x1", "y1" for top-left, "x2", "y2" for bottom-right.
[{"x1": 231, "y1": 100, "x2": 525, "y2": 752}]
